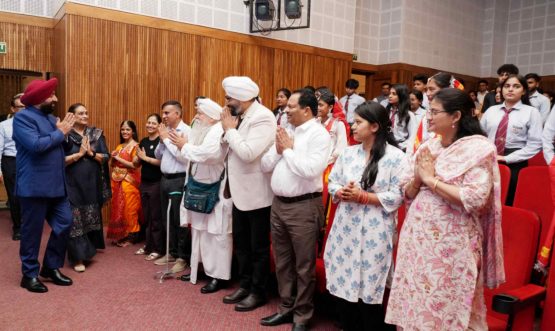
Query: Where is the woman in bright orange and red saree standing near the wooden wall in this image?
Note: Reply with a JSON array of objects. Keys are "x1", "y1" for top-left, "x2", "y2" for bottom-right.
[{"x1": 107, "y1": 121, "x2": 141, "y2": 247}]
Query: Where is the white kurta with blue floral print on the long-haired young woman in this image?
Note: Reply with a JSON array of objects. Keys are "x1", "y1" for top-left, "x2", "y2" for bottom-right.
[{"x1": 324, "y1": 145, "x2": 407, "y2": 304}]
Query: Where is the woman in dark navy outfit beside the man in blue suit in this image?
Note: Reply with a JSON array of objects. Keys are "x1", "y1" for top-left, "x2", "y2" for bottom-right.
[{"x1": 63, "y1": 103, "x2": 112, "y2": 272}]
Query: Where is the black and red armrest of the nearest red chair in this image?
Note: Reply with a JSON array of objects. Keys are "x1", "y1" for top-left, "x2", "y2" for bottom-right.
[{"x1": 492, "y1": 284, "x2": 546, "y2": 315}]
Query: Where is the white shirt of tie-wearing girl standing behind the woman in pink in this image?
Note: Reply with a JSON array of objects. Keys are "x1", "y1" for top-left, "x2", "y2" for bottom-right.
[{"x1": 480, "y1": 101, "x2": 542, "y2": 163}]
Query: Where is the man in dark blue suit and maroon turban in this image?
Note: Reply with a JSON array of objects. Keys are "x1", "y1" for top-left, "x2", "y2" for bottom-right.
[{"x1": 13, "y1": 78, "x2": 75, "y2": 293}]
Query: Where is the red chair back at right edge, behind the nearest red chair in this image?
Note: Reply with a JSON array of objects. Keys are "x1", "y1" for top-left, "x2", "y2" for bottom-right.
[{"x1": 513, "y1": 166, "x2": 554, "y2": 252}]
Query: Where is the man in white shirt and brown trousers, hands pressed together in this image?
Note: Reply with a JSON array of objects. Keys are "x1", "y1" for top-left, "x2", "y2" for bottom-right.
[{"x1": 260, "y1": 90, "x2": 331, "y2": 330}]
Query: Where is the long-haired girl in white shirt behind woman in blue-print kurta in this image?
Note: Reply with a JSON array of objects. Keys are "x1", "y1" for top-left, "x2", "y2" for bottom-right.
[{"x1": 387, "y1": 84, "x2": 418, "y2": 151}]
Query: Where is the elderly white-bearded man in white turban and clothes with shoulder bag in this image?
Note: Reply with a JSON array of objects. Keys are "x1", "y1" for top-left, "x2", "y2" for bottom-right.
[{"x1": 170, "y1": 99, "x2": 233, "y2": 293}]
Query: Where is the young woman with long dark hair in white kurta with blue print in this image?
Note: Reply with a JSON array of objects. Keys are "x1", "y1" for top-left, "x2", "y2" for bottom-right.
[{"x1": 324, "y1": 101, "x2": 406, "y2": 330}]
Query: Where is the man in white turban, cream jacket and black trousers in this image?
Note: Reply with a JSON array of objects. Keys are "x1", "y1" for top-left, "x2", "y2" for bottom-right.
[{"x1": 222, "y1": 76, "x2": 277, "y2": 311}]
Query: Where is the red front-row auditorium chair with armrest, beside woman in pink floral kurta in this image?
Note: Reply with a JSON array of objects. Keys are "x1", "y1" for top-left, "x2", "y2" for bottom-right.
[{"x1": 484, "y1": 206, "x2": 545, "y2": 331}]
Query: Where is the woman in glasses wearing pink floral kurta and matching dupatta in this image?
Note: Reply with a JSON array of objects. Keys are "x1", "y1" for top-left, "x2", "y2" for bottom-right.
[{"x1": 386, "y1": 88, "x2": 505, "y2": 331}]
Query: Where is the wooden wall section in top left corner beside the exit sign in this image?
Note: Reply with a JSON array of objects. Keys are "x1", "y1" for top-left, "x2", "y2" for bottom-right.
[{"x1": 0, "y1": 21, "x2": 53, "y2": 72}]
